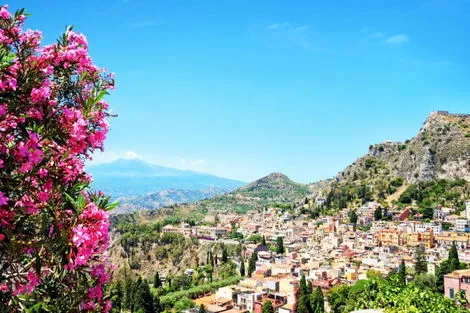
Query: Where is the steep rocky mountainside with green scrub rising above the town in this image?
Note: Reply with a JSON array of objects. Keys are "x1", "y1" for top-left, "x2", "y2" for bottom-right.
[{"x1": 328, "y1": 111, "x2": 470, "y2": 207}]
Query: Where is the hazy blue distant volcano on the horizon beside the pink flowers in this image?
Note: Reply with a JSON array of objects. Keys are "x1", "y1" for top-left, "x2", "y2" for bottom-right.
[{"x1": 88, "y1": 159, "x2": 244, "y2": 198}]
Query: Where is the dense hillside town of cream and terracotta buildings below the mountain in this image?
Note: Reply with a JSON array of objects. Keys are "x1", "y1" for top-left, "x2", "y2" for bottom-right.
[{"x1": 156, "y1": 197, "x2": 470, "y2": 313}]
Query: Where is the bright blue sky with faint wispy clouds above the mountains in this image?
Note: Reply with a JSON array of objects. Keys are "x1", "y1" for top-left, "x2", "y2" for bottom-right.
[{"x1": 9, "y1": 0, "x2": 470, "y2": 182}]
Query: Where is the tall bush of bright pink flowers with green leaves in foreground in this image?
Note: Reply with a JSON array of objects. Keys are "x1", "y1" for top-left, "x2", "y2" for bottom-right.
[{"x1": 0, "y1": 6, "x2": 114, "y2": 312}]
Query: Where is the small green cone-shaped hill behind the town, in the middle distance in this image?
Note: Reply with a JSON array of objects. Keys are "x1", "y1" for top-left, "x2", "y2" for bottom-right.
[{"x1": 155, "y1": 173, "x2": 313, "y2": 217}]
